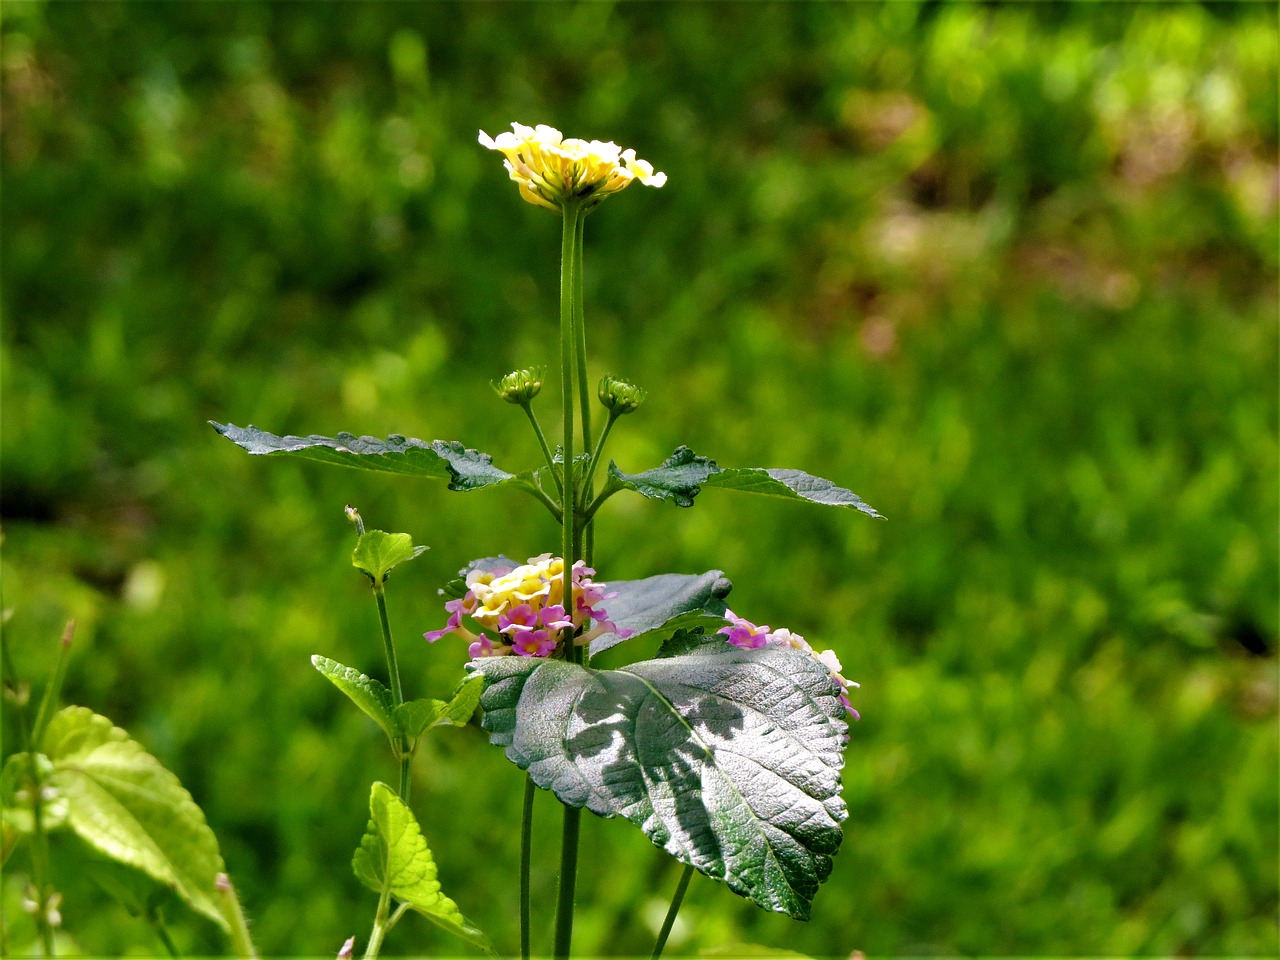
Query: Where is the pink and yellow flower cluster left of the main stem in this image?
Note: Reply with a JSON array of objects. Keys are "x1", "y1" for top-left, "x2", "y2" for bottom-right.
[{"x1": 422, "y1": 553, "x2": 631, "y2": 659}]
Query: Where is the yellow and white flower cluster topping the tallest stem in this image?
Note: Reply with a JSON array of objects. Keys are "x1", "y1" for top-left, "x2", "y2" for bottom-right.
[{"x1": 480, "y1": 123, "x2": 667, "y2": 210}]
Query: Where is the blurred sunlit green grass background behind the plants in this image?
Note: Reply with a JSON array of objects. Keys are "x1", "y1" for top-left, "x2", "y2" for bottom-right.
[{"x1": 0, "y1": 0, "x2": 1280, "y2": 956}]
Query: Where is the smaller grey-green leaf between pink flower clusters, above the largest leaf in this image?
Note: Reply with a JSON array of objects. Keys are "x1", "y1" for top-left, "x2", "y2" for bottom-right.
[{"x1": 591, "y1": 570, "x2": 733, "y2": 657}]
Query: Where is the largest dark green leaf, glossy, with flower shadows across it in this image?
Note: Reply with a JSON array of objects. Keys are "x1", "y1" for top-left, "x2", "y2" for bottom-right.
[{"x1": 471, "y1": 644, "x2": 846, "y2": 920}]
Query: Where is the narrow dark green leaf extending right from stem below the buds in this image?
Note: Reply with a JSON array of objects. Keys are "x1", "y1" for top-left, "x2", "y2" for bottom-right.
[{"x1": 609, "y1": 447, "x2": 881, "y2": 517}]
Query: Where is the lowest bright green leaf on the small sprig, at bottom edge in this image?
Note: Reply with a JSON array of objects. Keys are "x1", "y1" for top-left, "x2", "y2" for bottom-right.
[{"x1": 351, "y1": 782, "x2": 493, "y2": 954}]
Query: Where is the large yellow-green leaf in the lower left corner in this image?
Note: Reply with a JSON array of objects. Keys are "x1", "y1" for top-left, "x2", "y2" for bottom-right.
[{"x1": 45, "y1": 707, "x2": 228, "y2": 929}]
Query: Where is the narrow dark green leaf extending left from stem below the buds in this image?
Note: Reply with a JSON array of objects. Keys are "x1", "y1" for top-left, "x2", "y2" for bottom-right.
[{"x1": 210, "y1": 421, "x2": 529, "y2": 490}]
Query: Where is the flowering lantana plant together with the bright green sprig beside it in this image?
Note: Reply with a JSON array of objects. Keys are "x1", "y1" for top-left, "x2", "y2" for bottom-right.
[{"x1": 214, "y1": 123, "x2": 879, "y2": 957}]
